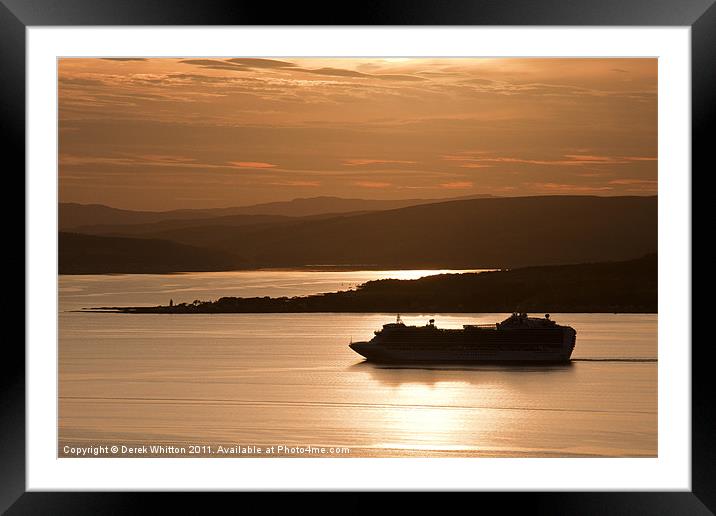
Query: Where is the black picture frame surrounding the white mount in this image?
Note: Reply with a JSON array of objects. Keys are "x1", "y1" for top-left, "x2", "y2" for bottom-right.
[{"x1": 0, "y1": 0, "x2": 704, "y2": 515}]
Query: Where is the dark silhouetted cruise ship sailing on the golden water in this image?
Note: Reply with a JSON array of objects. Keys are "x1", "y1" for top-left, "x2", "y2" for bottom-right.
[{"x1": 349, "y1": 313, "x2": 577, "y2": 363}]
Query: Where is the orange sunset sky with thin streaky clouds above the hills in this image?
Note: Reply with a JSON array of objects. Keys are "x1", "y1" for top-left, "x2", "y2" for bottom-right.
[{"x1": 59, "y1": 58, "x2": 657, "y2": 210}]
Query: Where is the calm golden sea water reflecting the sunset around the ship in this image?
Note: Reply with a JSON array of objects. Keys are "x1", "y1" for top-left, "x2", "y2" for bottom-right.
[{"x1": 58, "y1": 271, "x2": 657, "y2": 457}]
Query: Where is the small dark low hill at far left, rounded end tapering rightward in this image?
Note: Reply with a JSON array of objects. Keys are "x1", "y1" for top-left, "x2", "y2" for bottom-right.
[{"x1": 58, "y1": 232, "x2": 241, "y2": 274}]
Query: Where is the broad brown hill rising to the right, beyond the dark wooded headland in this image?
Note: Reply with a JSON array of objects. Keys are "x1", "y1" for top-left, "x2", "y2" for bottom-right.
[{"x1": 140, "y1": 196, "x2": 657, "y2": 268}]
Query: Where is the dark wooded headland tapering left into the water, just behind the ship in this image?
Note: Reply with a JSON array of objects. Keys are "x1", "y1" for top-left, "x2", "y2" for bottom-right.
[{"x1": 109, "y1": 254, "x2": 658, "y2": 314}]
